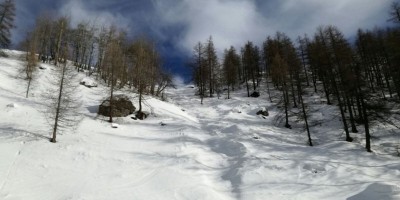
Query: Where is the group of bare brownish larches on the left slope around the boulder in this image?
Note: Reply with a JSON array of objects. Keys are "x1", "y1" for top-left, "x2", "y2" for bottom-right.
[{"x1": 17, "y1": 15, "x2": 172, "y2": 142}]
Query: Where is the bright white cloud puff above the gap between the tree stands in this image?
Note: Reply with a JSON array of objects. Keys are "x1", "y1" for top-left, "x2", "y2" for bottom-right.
[{"x1": 155, "y1": 0, "x2": 265, "y2": 51}]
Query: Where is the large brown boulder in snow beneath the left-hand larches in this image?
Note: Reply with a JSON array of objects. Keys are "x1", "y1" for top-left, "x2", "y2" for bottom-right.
[{"x1": 98, "y1": 95, "x2": 136, "y2": 117}]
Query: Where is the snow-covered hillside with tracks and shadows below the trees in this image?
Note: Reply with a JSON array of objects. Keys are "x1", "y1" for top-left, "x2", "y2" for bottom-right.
[{"x1": 0, "y1": 51, "x2": 400, "y2": 200}]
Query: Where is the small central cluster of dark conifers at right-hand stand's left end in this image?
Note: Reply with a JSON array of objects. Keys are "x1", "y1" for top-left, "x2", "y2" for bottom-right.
[{"x1": 191, "y1": 37, "x2": 262, "y2": 103}]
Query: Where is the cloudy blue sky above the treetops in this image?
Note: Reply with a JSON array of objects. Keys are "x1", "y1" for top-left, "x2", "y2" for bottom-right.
[{"x1": 12, "y1": 0, "x2": 399, "y2": 79}]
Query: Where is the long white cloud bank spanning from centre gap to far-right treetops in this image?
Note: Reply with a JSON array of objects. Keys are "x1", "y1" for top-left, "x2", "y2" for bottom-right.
[{"x1": 154, "y1": 0, "x2": 391, "y2": 52}]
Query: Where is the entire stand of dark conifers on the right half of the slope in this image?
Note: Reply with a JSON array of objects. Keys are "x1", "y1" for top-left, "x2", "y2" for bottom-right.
[{"x1": 193, "y1": 3, "x2": 400, "y2": 151}]
